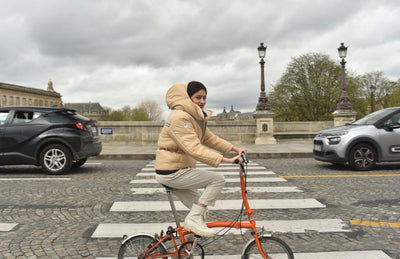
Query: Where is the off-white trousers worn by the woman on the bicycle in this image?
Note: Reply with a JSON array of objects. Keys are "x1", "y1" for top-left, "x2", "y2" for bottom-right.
[{"x1": 156, "y1": 168, "x2": 225, "y2": 209}]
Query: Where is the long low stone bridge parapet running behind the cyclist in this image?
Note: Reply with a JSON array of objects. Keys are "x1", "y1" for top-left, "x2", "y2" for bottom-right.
[{"x1": 98, "y1": 121, "x2": 334, "y2": 145}]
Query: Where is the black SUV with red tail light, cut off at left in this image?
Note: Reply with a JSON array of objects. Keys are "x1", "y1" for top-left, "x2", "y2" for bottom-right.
[{"x1": 0, "y1": 107, "x2": 102, "y2": 174}]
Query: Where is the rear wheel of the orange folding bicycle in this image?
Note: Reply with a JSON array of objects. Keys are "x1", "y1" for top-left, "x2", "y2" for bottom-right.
[{"x1": 118, "y1": 235, "x2": 168, "y2": 259}]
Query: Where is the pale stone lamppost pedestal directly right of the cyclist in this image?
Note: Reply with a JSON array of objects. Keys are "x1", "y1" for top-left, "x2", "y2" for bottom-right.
[{"x1": 253, "y1": 110, "x2": 276, "y2": 145}]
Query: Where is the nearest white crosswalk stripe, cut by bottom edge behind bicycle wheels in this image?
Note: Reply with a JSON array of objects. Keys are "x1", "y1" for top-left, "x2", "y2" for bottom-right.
[{"x1": 96, "y1": 251, "x2": 390, "y2": 259}]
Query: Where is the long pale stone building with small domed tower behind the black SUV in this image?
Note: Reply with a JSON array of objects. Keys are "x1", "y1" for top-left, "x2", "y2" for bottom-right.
[{"x1": 0, "y1": 81, "x2": 62, "y2": 107}]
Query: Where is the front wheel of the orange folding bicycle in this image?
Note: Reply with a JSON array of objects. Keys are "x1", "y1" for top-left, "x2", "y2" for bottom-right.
[{"x1": 242, "y1": 236, "x2": 294, "y2": 259}]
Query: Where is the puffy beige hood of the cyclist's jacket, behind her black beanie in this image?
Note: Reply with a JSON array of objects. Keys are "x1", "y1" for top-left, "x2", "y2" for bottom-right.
[{"x1": 165, "y1": 83, "x2": 212, "y2": 120}]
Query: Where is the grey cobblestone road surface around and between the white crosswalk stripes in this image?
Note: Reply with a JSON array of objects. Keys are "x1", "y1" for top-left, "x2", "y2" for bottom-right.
[{"x1": 0, "y1": 158, "x2": 400, "y2": 258}]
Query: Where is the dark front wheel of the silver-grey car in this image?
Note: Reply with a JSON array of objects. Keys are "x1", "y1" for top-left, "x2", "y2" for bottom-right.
[{"x1": 349, "y1": 144, "x2": 377, "y2": 171}]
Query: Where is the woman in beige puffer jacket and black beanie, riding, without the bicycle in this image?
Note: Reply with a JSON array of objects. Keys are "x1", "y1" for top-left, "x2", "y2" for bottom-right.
[{"x1": 155, "y1": 81, "x2": 247, "y2": 237}]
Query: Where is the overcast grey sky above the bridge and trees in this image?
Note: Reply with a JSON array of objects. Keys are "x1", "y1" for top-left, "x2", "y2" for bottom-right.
[{"x1": 0, "y1": 0, "x2": 400, "y2": 118}]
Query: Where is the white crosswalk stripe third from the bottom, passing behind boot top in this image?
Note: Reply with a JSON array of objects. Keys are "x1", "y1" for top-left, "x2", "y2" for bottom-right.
[{"x1": 110, "y1": 199, "x2": 326, "y2": 212}]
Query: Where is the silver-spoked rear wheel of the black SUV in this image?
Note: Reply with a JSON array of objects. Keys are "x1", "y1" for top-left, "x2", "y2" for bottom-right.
[{"x1": 40, "y1": 144, "x2": 72, "y2": 174}]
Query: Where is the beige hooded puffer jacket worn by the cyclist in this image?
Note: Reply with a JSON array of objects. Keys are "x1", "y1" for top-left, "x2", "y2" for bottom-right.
[{"x1": 155, "y1": 84, "x2": 233, "y2": 170}]
